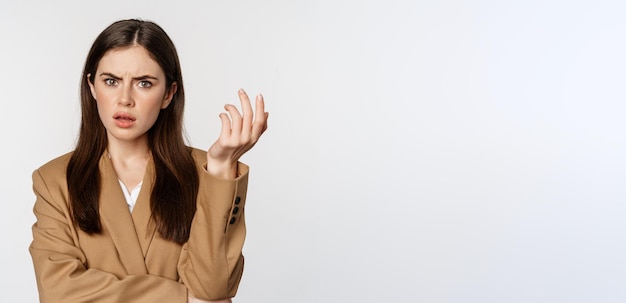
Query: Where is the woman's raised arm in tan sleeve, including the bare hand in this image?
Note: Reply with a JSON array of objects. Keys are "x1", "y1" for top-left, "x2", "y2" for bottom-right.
[{"x1": 179, "y1": 89, "x2": 268, "y2": 300}]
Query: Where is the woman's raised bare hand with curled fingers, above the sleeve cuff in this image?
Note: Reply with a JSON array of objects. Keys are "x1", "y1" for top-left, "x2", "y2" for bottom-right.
[{"x1": 207, "y1": 89, "x2": 269, "y2": 179}]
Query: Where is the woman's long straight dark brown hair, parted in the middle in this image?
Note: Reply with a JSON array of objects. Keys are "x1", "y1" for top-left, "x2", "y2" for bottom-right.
[{"x1": 67, "y1": 19, "x2": 199, "y2": 244}]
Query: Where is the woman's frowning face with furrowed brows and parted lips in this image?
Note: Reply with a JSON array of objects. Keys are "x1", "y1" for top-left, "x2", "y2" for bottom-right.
[{"x1": 88, "y1": 46, "x2": 176, "y2": 147}]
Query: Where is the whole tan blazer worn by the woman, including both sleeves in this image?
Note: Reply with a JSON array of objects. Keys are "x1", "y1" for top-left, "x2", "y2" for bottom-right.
[{"x1": 29, "y1": 149, "x2": 248, "y2": 303}]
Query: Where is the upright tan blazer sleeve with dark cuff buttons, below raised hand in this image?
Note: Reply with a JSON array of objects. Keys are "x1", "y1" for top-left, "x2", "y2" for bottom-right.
[{"x1": 178, "y1": 163, "x2": 248, "y2": 300}]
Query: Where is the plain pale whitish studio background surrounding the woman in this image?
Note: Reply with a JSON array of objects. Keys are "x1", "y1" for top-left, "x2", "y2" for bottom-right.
[{"x1": 0, "y1": 0, "x2": 626, "y2": 302}]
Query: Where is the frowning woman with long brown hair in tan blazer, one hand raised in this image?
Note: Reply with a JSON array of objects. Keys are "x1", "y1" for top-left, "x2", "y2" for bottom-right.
[{"x1": 30, "y1": 20, "x2": 268, "y2": 303}]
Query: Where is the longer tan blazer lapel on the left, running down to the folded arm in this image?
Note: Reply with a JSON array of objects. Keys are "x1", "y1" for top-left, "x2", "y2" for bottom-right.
[{"x1": 100, "y1": 153, "x2": 147, "y2": 275}]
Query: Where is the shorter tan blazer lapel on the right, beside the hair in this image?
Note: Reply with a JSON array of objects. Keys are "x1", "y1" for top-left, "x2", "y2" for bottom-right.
[{"x1": 132, "y1": 157, "x2": 156, "y2": 258}]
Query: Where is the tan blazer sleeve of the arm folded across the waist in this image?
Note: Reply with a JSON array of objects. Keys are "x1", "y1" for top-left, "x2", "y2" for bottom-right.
[{"x1": 29, "y1": 170, "x2": 187, "y2": 303}]
